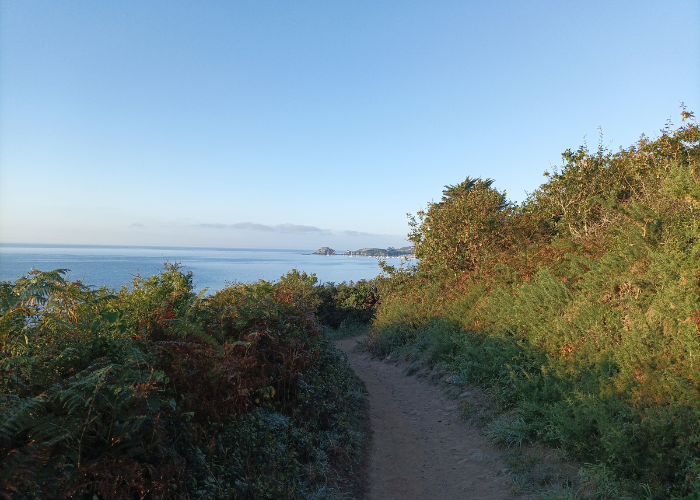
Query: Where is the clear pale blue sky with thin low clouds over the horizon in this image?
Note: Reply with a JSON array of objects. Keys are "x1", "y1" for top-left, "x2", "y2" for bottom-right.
[{"x1": 0, "y1": 0, "x2": 700, "y2": 250}]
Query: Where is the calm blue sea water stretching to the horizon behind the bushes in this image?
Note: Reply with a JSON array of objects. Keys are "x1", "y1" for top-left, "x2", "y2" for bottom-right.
[{"x1": 0, "y1": 244, "x2": 410, "y2": 292}]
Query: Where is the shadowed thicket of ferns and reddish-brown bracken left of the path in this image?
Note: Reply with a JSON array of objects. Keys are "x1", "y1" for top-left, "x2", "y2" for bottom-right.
[{"x1": 0, "y1": 266, "x2": 371, "y2": 499}]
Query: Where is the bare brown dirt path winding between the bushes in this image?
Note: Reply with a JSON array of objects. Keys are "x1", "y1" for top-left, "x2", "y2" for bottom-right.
[{"x1": 336, "y1": 339, "x2": 510, "y2": 500}]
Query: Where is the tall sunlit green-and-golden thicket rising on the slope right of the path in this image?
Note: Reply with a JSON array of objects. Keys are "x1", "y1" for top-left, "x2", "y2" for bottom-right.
[{"x1": 372, "y1": 111, "x2": 700, "y2": 498}]
